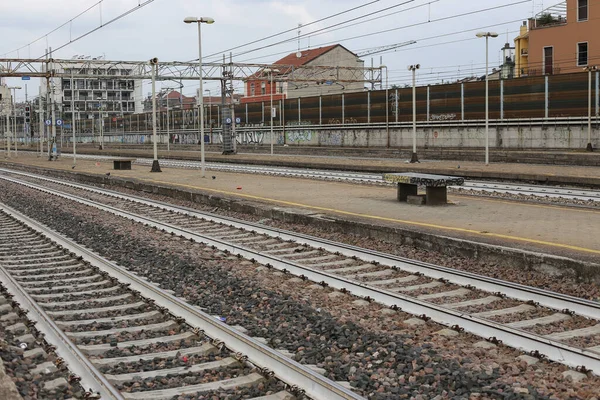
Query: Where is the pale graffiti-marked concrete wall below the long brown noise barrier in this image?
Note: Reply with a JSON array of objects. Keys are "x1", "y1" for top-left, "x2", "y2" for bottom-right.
[{"x1": 66, "y1": 124, "x2": 600, "y2": 150}]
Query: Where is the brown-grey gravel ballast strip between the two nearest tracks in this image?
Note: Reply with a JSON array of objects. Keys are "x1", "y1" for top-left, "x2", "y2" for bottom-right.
[{"x1": 0, "y1": 183, "x2": 598, "y2": 399}]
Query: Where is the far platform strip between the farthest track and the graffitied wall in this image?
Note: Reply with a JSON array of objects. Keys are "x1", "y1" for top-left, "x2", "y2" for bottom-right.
[{"x1": 45, "y1": 145, "x2": 600, "y2": 188}]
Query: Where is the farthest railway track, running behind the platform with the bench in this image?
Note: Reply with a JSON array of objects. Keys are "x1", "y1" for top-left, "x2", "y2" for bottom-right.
[{"x1": 43, "y1": 154, "x2": 600, "y2": 202}]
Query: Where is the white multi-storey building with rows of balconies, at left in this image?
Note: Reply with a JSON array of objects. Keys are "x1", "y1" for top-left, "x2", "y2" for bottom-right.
[{"x1": 42, "y1": 57, "x2": 143, "y2": 120}]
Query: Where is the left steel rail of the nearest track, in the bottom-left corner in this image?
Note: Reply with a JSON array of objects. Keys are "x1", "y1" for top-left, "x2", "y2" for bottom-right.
[{"x1": 0, "y1": 231, "x2": 124, "y2": 400}]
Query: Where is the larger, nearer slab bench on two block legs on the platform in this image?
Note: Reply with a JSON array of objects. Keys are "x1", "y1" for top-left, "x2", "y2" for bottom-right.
[{"x1": 383, "y1": 172, "x2": 465, "y2": 206}]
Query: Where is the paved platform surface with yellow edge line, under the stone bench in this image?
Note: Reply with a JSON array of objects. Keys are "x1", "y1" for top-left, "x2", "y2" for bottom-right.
[{"x1": 0, "y1": 154, "x2": 600, "y2": 262}]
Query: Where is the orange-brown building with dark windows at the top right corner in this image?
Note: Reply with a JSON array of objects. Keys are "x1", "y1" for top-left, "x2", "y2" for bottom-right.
[{"x1": 517, "y1": 0, "x2": 600, "y2": 76}]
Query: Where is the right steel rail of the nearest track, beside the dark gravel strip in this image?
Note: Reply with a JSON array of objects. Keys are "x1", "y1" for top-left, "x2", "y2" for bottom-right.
[{"x1": 0, "y1": 203, "x2": 363, "y2": 400}]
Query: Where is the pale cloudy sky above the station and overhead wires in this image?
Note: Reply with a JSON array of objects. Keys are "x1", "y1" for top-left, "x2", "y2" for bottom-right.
[{"x1": 0, "y1": 0, "x2": 536, "y2": 101}]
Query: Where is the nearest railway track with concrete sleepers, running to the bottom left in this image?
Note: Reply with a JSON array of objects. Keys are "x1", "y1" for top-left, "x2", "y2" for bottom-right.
[{"x1": 0, "y1": 205, "x2": 362, "y2": 400}]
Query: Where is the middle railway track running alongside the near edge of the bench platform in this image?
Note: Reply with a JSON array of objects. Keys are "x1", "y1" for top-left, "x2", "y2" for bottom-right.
[{"x1": 0, "y1": 167, "x2": 600, "y2": 372}]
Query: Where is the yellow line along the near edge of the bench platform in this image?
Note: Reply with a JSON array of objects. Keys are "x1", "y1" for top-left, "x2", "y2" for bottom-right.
[{"x1": 137, "y1": 178, "x2": 600, "y2": 254}]
